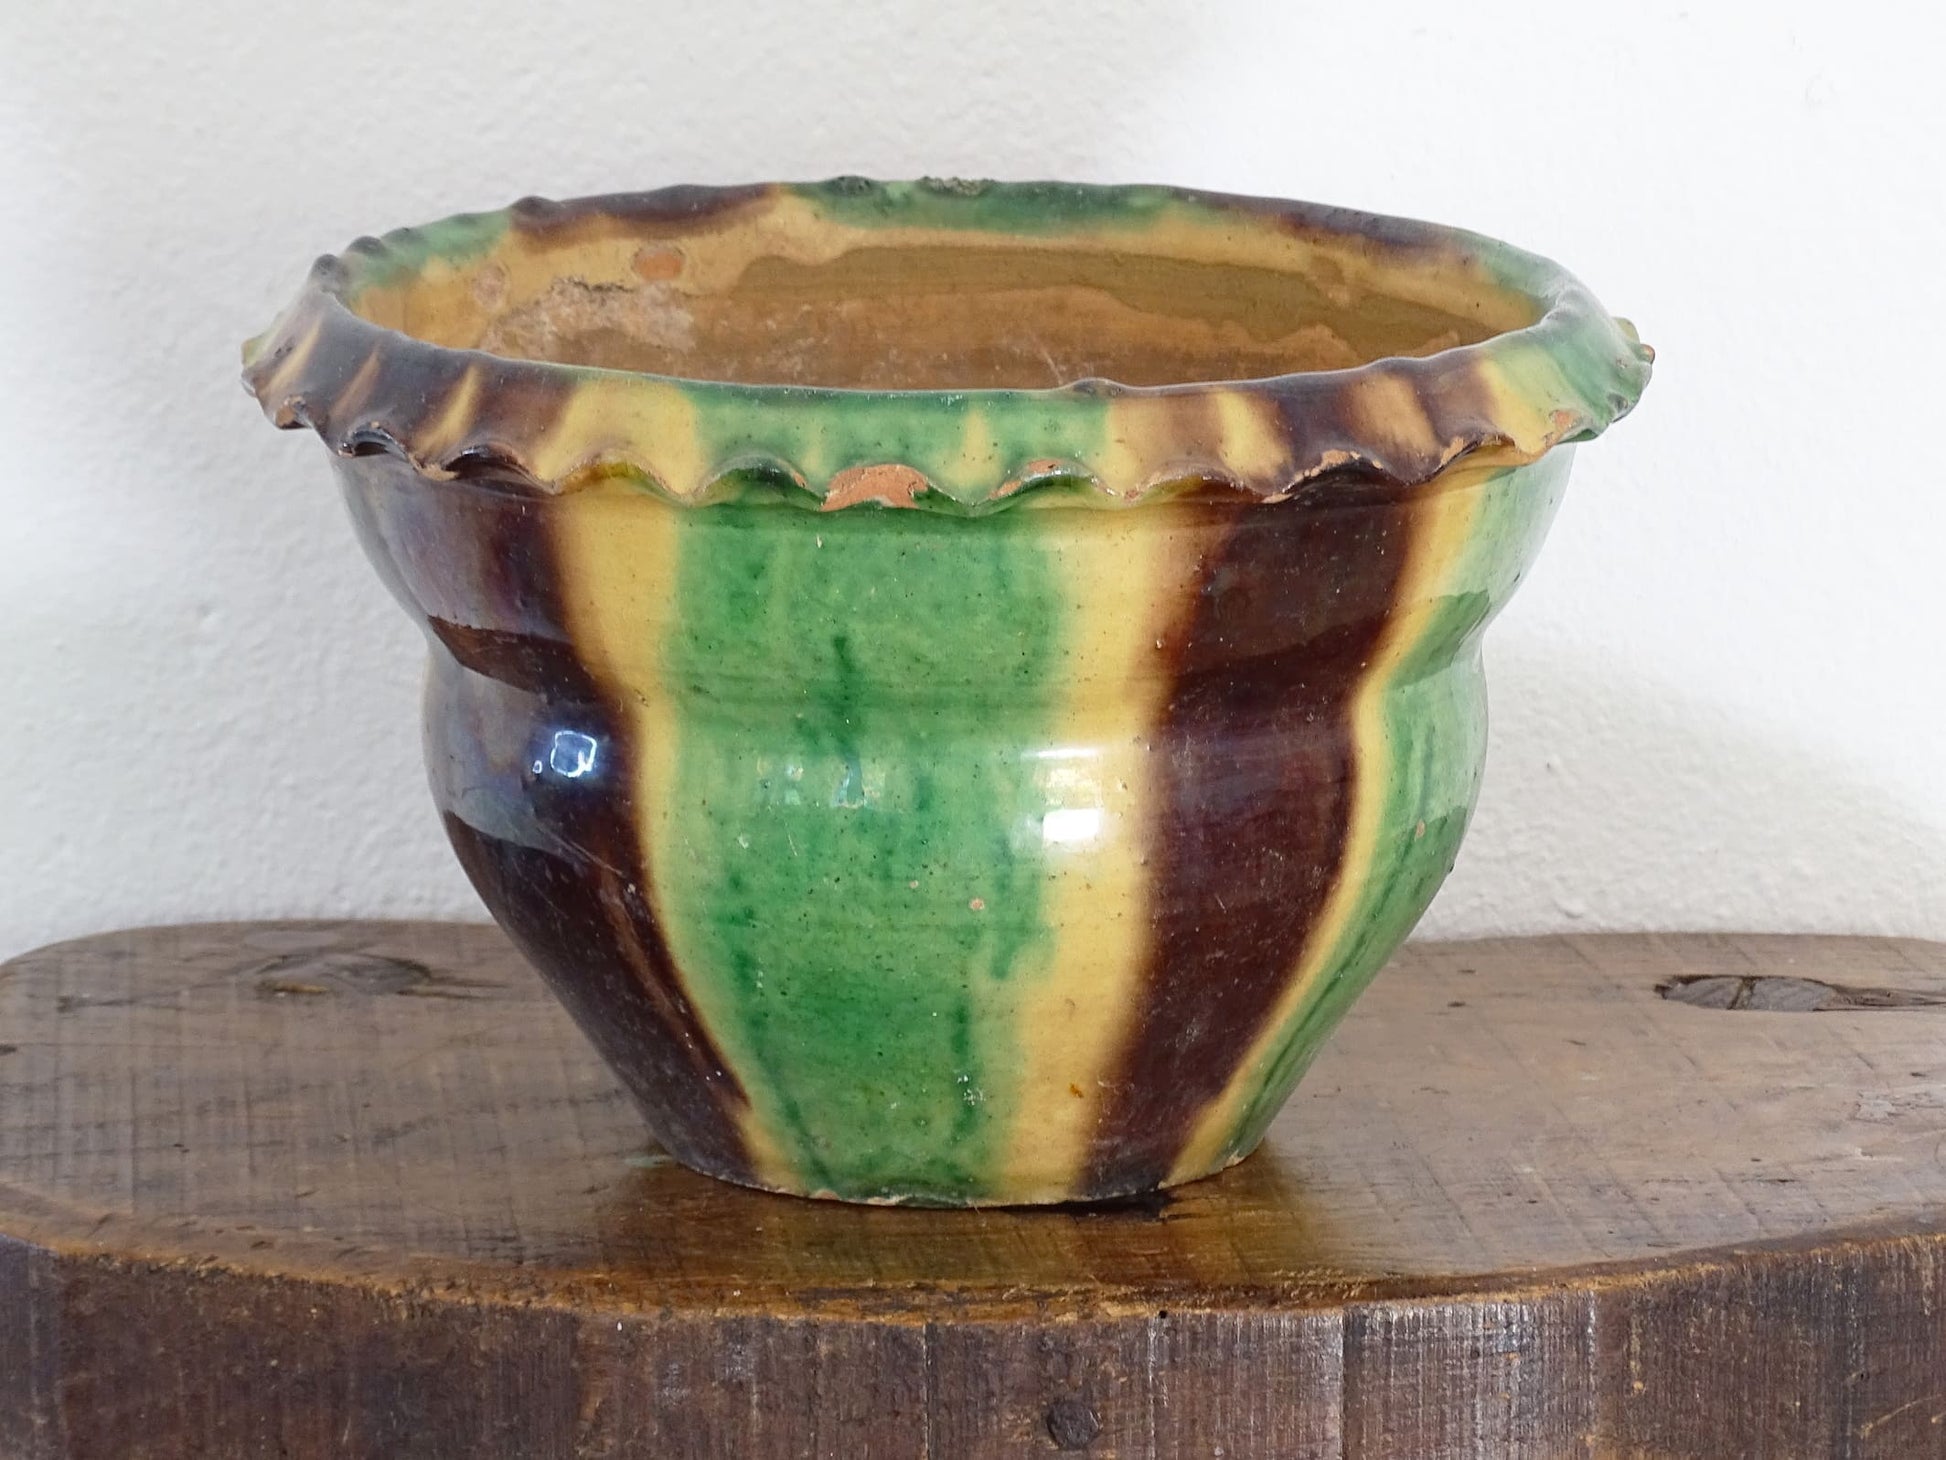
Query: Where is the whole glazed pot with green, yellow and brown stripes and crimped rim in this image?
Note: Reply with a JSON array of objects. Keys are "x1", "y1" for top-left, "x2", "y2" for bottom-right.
[{"x1": 245, "y1": 179, "x2": 1650, "y2": 1205}]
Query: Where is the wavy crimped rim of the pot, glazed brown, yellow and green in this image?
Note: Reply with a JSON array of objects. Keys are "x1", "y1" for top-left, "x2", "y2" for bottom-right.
[{"x1": 243, "y1": 179, "x2": 1654, "y2": 512}]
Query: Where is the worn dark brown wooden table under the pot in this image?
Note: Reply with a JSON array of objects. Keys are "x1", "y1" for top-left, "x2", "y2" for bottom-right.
[{"x1": 0, "y1": 923, "x2": 1946, "y2": 1460}]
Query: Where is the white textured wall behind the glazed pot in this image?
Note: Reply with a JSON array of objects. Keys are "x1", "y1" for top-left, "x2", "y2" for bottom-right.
[{"x1": 0, "y1": 0, "x2": 1946, "y2": 954}]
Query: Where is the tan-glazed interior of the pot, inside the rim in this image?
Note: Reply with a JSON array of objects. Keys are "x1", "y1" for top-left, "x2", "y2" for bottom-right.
[{"x1": 360, "y1": 211, "x2": 1535, "y2": 389}]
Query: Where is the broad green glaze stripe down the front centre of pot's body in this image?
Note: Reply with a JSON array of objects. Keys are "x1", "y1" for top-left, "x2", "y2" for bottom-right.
[{"x1": 654, "y1": 506, "x2": 1063, "y2": 1201}]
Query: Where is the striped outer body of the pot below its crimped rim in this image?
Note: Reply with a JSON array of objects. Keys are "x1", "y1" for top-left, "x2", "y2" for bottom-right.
[{"x1": 383, "y1": 451, "x2": 1565, "y2": 1205}]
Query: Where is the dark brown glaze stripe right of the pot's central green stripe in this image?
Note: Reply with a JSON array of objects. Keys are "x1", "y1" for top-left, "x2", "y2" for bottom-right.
[{"x1": 1086, "y1": 500, "x2": 1409, "y2": 1195}]
